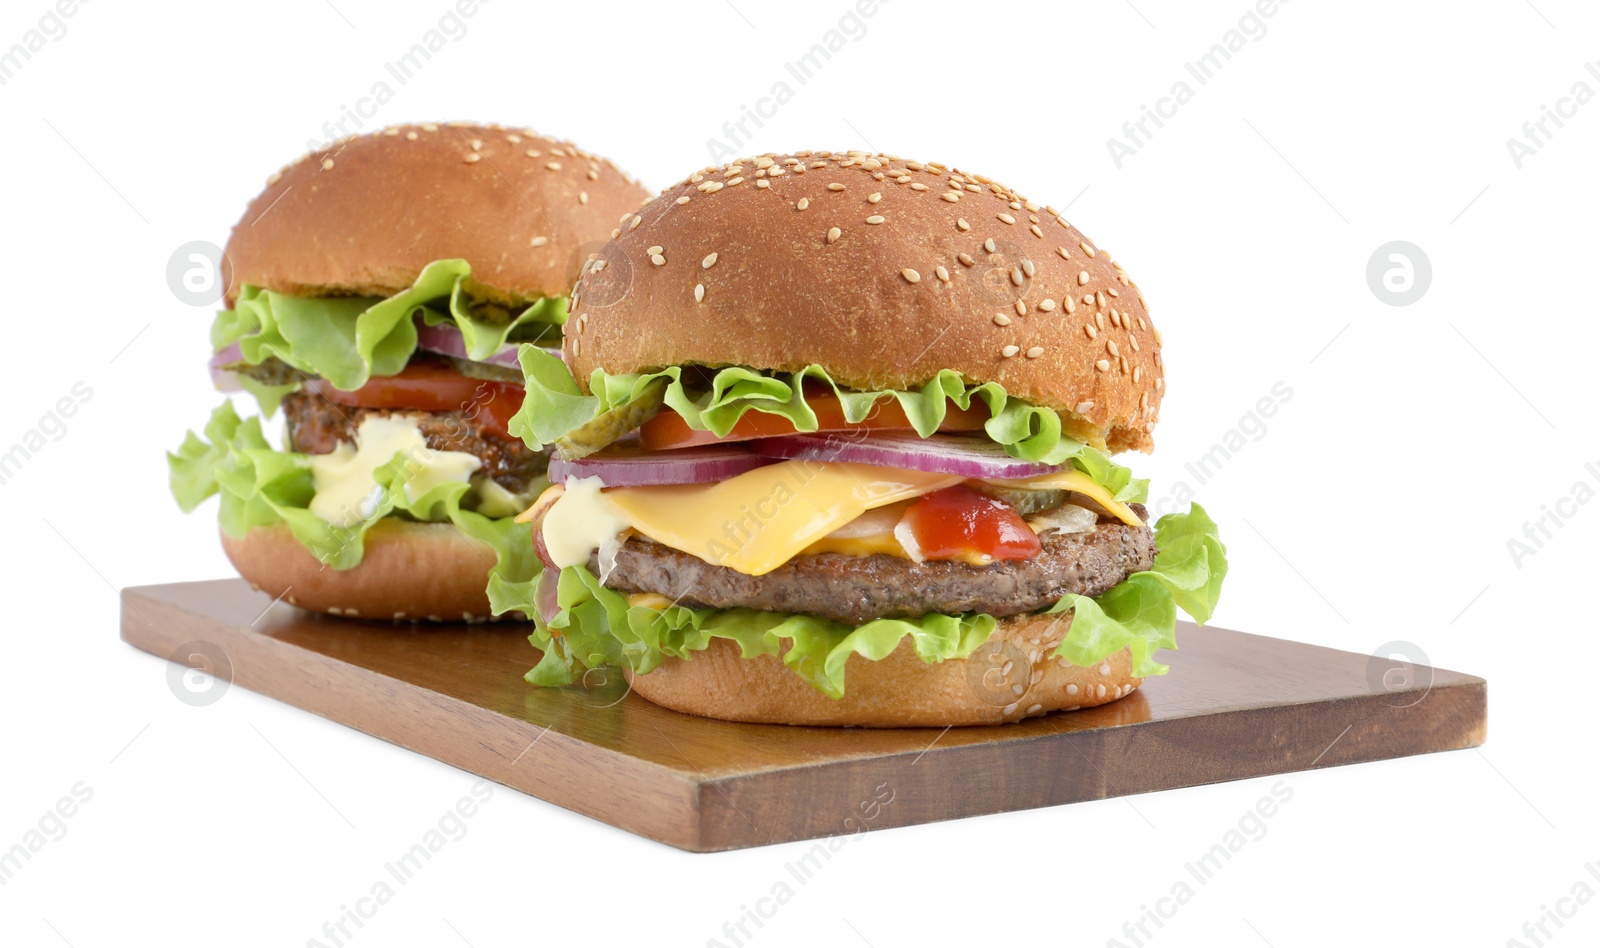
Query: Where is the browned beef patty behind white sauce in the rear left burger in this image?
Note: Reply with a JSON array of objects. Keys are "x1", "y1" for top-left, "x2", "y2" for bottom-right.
[{"x1": 283, "y1": 392, "x2": 550, "y2": 493}]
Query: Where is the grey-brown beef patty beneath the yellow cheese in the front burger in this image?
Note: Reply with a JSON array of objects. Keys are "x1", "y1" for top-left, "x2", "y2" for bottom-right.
[{"x1": 589, "y1": 504, "x2": 1155, "y2": 625}]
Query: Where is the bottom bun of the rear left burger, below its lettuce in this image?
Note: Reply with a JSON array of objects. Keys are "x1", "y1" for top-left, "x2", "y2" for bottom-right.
[{"x1": 222, "y1": 519, "x2": 515, "y2": 621}]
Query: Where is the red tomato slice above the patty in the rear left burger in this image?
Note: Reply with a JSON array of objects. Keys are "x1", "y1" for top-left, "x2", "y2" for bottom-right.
[{"x1": 306, "y1": 362, "x2": 523, "y2": 440}]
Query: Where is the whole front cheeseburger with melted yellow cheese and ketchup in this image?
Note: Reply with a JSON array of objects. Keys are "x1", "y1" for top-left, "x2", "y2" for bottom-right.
[{"x1": 510, "y1": 151, "x2": 1227, "y2": 727}]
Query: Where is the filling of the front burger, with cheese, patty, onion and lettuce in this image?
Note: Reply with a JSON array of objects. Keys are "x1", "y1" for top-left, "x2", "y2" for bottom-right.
[{"x1": 490, "y1": 351, "x2": 1226, "y2": 697}]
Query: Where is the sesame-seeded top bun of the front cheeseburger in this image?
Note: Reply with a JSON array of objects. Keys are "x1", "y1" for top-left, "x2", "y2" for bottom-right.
[{"x1": 565, "y1": 152, "x2": 1165, "y2": 450}]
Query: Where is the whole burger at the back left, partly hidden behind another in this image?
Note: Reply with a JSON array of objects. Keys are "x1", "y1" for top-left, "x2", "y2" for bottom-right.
[{"x1": 168, "y1": 123, "x2": 648, "y2": 621}]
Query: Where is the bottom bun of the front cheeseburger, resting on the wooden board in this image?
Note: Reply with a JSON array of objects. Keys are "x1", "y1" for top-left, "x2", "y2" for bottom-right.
[{"x1": 629, "y1": 613, "x2": 1142, "y2": 727}]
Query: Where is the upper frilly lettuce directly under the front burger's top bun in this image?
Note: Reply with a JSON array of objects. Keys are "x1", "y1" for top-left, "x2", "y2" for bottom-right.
[{"x1": 510, "y1": 346, "x2": 1149, "y2": 503}]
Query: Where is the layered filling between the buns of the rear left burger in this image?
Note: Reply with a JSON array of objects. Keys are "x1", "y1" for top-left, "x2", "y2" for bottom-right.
[{"x1": 168, "y1": 261, "x2": 565, "y2": 583}]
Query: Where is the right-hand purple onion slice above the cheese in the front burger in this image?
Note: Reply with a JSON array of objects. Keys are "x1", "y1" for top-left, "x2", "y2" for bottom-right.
[{"x1": 754, "y1": 431, "x2": 1059, "y2": 477}]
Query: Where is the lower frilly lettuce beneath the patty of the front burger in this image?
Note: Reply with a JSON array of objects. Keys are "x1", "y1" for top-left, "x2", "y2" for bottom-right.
[{"x1": 512, "y1": 504, "x2": 1227, "y2": 698}]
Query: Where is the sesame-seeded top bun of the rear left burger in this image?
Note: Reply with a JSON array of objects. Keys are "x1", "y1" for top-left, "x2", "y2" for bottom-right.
[{"x1": 224, "y1": 122, "x2": 648, "y2": 306}]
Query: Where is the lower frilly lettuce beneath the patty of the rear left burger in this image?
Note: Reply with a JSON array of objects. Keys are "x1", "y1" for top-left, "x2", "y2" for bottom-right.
[{"x1": 166, "y1": 402, "x2": 539, "y2": 595}]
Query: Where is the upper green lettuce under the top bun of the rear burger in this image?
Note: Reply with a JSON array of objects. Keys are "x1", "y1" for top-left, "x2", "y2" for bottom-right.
[{"x1": 211, "y1": 259, "x2": 566, "y2": 393}]
